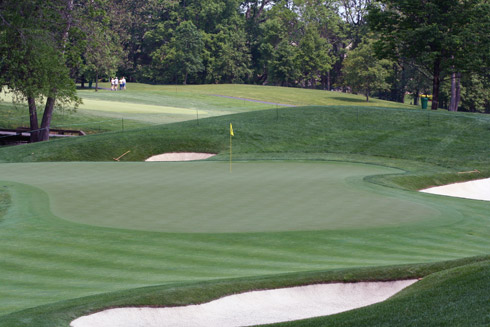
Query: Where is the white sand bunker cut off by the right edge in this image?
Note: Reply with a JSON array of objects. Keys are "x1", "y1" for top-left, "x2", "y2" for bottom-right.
[{"x1": 420, "y1": 178, "x2": 490, "y2": 201}]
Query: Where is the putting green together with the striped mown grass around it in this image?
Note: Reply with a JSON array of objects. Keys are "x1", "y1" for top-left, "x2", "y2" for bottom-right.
[{"x1": 0, "y1": 160, "x2": 489, "y2": 314}]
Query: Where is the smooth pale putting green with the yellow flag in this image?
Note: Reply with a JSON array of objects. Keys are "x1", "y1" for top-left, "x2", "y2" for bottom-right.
[{"x1": 0, "y1": 162, "x2": 440, "y2": 233}]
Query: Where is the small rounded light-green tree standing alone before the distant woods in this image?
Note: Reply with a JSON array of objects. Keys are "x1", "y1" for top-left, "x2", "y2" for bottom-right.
[{"x1": 342, "y1": 41, "x2": 392, "y2": 101}]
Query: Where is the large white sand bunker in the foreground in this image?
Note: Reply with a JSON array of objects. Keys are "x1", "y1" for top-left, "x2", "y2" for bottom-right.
[{"x1": 70, "y1": 280, "x2": 416, "y2": 327}]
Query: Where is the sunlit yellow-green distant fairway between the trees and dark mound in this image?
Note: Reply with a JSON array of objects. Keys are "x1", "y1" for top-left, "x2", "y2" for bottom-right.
[{"x1": 0, "y1": 84, "x2": 416, "y2": 134}]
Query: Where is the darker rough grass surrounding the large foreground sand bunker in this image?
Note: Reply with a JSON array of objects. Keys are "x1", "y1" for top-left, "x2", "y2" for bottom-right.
[{"x1": 0, "y1": 256, "x2": 490, "y2": 327}]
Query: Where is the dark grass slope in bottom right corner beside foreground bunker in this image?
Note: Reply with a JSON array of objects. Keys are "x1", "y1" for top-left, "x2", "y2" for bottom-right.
[{"x1": 268, "y1": 260, "x2": 490, "y2": 327}]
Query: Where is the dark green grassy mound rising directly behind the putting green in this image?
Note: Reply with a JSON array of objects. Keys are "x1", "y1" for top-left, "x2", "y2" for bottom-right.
[{"x1": 0, "y1": 107, "x2": 490, "y2": 189}]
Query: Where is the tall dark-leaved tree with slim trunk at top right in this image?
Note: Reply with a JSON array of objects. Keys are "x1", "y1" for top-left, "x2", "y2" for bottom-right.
[{"x1": 368, "y1": 0, "x2": 490, "y2": 110}]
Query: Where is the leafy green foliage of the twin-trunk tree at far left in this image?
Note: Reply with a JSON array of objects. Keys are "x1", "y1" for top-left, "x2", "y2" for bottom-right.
[{"x1": 0, "y1": 1, "x2": 78, "y2": 102}]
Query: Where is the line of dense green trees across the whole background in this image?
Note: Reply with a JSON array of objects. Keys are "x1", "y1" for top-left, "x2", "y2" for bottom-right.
[{"x1": 0, "y1": 0, "x2": 490, "y2": 139}]
